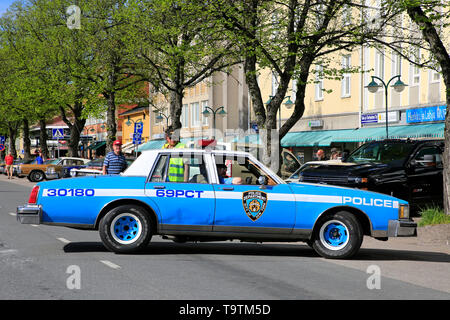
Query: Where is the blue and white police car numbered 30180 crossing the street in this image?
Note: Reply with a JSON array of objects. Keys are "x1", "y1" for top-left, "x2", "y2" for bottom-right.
[{"x1": 17, "y1": 149, "x2": 417, "y2": 258}]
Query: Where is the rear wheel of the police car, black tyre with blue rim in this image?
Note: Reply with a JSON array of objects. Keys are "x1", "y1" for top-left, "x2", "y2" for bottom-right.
[{"x1": 99, "y1": 205, "x2": 152, "y2": 253}]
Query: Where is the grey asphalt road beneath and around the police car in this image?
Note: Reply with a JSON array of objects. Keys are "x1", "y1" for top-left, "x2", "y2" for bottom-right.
[{"x1": 0, "y1": 175, "x2": 450, "y2": 300}]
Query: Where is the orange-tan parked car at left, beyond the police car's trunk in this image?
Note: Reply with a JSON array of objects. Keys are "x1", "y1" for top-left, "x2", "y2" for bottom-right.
[{"x1": 17, "y1": 157, "x2": 89, "y2": 182}]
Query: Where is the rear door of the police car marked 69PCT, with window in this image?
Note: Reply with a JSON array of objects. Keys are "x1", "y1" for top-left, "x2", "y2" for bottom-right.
[{"x1": 145, "y1": 152, "x2": 214, "y2": 231}]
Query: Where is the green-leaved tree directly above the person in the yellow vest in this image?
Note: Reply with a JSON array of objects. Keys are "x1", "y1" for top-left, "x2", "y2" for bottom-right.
[{"x1": 125, "y1": 0, "x2": 238, "y2": 130}]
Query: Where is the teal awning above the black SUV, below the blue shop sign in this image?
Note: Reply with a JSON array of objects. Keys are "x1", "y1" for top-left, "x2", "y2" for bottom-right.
[{"x1": 333, "y1": 122, "x2": 445, "y2": 142}]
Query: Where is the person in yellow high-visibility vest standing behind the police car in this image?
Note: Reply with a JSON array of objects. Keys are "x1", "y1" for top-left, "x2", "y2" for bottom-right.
[{"x1": 163, "y1": 131, "x2": 189, "y2": 182}]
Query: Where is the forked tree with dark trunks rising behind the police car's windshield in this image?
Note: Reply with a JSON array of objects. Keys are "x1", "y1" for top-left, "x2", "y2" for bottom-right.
[{"x1": 208, "y1": 0, "x2": 390, "y2": 170}]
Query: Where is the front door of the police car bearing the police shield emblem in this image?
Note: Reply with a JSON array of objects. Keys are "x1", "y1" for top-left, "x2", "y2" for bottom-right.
[{"x1": 213, "y1": 155, "x2": 296, "y2": 235}]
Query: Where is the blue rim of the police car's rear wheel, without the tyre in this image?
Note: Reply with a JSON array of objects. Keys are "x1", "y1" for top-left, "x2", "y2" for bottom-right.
[{"x1": 111, "y1": 214, "x2": 142, "y2": 244}]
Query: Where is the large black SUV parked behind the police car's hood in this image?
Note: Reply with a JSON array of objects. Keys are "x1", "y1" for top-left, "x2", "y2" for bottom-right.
[{"x1": 288, "y1": 140, "x2": 444, "y2": 211}]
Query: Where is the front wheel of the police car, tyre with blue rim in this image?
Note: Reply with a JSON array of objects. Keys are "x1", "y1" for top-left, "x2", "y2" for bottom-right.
[{"x1": 312, "y1": 211, "x2": 364, "y2": 259}]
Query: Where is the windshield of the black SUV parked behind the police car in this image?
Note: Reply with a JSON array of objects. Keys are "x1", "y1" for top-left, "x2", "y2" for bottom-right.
[{"x1": 345, "y1": 142, "x2": 413, "y2": 163}]
